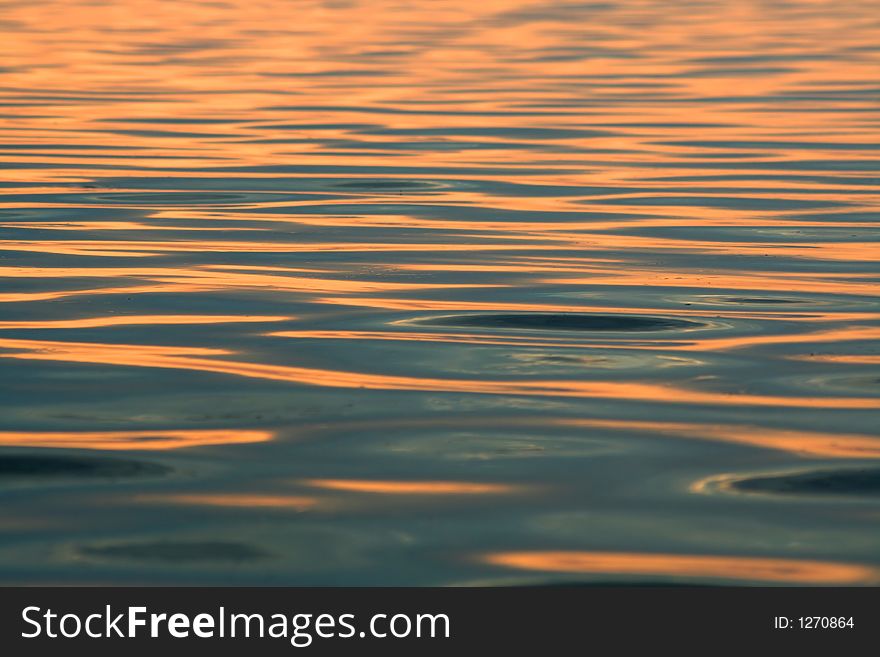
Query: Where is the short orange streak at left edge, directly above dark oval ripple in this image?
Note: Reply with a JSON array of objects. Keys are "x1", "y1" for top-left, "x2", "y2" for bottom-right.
[{"x1": 0, "y1": 429, "x2": 274, "y2": 451}]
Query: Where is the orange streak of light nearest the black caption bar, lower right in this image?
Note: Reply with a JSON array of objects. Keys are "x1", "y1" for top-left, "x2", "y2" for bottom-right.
[{"x1": 480, "y1": 551, "x2": 878, "y2": 585}]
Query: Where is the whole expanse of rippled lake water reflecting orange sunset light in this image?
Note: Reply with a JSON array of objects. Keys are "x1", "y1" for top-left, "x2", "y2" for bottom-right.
[{"x1": 0, "y1": 0, "x2": 880, "y2": 585}]
